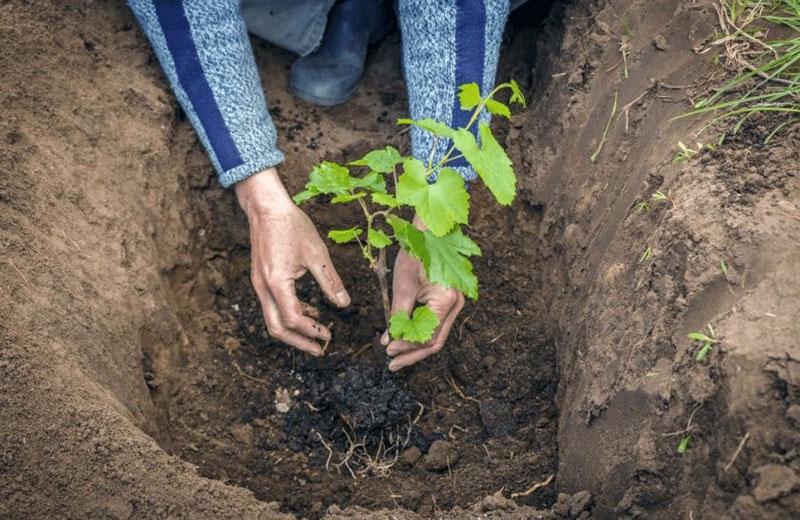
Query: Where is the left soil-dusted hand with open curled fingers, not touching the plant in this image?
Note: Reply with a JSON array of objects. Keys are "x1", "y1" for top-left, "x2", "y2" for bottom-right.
[{"x1": 235, "y1": 168, "x2": 350, "y2": 356}]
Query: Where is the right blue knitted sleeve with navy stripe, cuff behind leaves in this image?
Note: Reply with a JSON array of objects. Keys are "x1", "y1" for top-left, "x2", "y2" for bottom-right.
[{"x1": 398, "y1": 0, "x2": 509, "y2": 180}]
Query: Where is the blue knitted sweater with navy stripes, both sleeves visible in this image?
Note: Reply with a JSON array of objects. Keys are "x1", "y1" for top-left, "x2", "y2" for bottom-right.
[{"x1": 128, "y1": 0, "x2": 509, "y2": 187}]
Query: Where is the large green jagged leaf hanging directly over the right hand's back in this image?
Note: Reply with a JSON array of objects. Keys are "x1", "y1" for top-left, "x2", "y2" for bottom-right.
[{"x1": 422, "y1": 227, "x2": 481, "y2": 300}]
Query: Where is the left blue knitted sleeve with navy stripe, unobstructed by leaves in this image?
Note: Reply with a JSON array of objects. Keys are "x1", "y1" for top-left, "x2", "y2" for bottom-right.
[{"x1": 128, "y1": 0, "x2": 283, "y2": 187}]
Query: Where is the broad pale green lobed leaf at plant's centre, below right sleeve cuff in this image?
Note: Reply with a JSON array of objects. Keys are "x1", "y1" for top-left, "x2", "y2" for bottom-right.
[{"x1": 397, "y1": 159, "x2": 469, "y2": 236}]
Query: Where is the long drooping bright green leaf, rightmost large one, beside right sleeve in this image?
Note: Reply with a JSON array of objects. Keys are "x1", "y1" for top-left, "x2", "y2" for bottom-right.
[{"x1": 453, "y1": 123, "x2": 517, "y2": 206}]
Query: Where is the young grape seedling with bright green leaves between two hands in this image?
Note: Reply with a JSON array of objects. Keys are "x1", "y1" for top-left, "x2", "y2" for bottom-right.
[{"x1": 294, "y1": 80, "x2": 525, "y2": 343}]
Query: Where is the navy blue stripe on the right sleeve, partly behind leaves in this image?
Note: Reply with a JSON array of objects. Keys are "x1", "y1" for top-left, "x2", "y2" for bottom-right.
[{"x1": 450, "y1": 0, "x2": 486, "y2": 166}]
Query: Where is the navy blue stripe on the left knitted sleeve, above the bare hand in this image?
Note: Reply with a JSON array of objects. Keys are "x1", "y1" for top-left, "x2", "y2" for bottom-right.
[{"x1": 154, "y1": 0, "x2": 244, "y2": 171}]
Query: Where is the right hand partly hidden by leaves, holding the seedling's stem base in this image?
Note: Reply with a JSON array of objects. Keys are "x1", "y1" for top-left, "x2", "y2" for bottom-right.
[{"x1": 381, "y1": 219, "x2": 464, "y2": 372}]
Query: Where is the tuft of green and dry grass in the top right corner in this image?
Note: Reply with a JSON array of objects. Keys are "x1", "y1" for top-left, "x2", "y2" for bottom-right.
[{"x1": 679, "y1": 0, "x2": 800, "y2": 143}]
